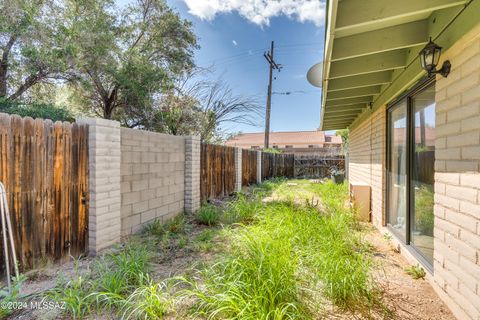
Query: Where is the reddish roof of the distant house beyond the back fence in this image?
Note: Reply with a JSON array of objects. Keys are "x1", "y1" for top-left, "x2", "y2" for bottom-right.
[{"x1": 225, "y1": 131, "x2": 342, "y2": 147}]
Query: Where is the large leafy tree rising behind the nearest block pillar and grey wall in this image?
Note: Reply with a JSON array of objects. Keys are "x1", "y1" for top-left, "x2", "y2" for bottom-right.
[{"x1": 67, "y1": 0, "x2": 197, "y2": 119}]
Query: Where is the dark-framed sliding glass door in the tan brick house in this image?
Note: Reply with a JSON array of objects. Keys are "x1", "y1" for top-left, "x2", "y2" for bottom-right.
[{"x1": 386, "y1": 81, "x2": 435, "y2": 269}]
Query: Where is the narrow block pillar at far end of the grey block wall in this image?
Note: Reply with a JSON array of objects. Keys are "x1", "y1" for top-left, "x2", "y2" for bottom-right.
[{"x1": 185, "y1": 136, "x2": 201, "y2": 213}]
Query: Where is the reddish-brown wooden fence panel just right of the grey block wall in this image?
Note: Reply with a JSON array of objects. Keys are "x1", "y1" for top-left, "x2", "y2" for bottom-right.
[{"x1": 200, "y1": 143, "x2": 235, "y2": 200}]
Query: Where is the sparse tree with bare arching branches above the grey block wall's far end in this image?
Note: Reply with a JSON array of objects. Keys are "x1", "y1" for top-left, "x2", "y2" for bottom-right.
[{"x1": 125, "y1": 68, "x2": 263, "y2": 142}]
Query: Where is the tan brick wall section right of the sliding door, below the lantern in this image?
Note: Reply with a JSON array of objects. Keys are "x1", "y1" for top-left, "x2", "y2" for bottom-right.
[{"x1": 434, "y1": 25, "x2": 480, "y2": 319}]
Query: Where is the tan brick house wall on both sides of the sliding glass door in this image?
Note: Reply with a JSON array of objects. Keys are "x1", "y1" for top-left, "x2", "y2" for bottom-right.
[{"x1": 349, "y1": 25, "x2": 480, "y2": 319}]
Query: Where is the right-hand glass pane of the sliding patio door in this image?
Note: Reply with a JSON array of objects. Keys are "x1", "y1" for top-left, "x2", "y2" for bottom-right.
[{"x1": 410, "y1": 86, "x2": 435, "y2": 264}]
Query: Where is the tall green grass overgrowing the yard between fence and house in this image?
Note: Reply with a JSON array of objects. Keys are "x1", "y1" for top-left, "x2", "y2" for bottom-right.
[{"x1": 44, "y1": 180, "x2": 381, "y2": 320}]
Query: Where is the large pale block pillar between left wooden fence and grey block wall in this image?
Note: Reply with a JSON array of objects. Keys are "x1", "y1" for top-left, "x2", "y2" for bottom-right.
[{"x1": 77, "y1": 118, "x2": 122, "y2": 255}]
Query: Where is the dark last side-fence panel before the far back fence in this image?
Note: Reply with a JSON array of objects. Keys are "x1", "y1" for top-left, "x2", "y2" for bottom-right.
[{"x1": 262, "y1": 152, "x2": 295, "y2": 180}]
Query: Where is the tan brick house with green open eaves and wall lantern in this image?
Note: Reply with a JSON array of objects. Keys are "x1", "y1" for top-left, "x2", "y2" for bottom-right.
[{"x1": 308, "y1": 0, "x2": 480, "y2": 320}]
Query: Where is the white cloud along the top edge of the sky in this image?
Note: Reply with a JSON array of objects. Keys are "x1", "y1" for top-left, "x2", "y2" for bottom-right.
[{"x1": 183, "y1": 0, "x2": 325, "y2": 26}]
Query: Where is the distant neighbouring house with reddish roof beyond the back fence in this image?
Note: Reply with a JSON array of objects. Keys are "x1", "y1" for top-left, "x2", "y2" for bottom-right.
[{"x1": 225, "y1": 130, "x2": 342, "y2": 156}]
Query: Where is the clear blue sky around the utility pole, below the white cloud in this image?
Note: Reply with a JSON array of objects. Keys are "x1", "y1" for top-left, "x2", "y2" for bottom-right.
[{"x1": 168, "y1": 0, "x2": 324, "y2": 132}]
